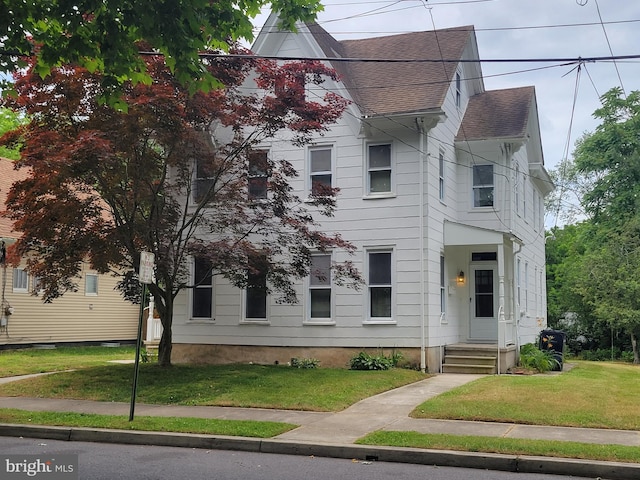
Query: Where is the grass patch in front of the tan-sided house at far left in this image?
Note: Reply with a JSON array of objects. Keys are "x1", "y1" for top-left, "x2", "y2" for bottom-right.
[{"x1": 0, "y1": 346, "x2": 136, "y2": 377}]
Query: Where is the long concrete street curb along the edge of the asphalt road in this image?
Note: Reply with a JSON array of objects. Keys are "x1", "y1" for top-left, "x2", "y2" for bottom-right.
[{"x1": 0, "y1": 424, "x2": 640, "y2": 480}]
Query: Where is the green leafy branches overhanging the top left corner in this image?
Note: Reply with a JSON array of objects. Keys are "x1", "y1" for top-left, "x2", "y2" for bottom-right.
[{"x1": 0, "y1": 0, "x2": 322, "y2": 92}]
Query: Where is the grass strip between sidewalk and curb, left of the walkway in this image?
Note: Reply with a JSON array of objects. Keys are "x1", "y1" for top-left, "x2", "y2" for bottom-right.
[{"x1": 0, "y1": 408, "x2": 297, "y2": 438}]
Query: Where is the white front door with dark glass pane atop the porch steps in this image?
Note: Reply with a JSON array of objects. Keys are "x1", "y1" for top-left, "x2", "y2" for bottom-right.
[{"x1": 469, "y1": 263, "x2": 498, "y2": 343}]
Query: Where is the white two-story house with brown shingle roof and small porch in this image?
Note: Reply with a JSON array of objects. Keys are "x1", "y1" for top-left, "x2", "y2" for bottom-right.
[{"x1": 173, "y1": 15, "x2": 553, "y2": 372}]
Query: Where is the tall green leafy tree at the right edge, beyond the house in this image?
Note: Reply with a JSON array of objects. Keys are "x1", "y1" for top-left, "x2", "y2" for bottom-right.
[{"x1": 574, "y1": 88, "x2": 640, "y2": 363}]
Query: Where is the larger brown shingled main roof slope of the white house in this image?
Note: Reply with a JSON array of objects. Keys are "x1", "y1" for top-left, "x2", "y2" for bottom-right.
[{"x1": 307, "y1": 23, "x2": 475, "y2": 116}]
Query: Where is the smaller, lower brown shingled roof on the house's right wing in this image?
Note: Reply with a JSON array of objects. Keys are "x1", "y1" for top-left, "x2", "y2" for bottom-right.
[{"x1": 456, "y1": 87, "x2": 535, "y2": 141}]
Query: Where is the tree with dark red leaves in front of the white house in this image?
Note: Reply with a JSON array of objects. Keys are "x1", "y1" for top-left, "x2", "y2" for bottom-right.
[{"x1": 0, "y1": 48, "x2": 360, "y2": 366}]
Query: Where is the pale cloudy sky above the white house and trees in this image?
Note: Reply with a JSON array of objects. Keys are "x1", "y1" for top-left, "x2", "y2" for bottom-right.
[{"x1": 250, "y1": 0, "x2": 640, "y2": 169}]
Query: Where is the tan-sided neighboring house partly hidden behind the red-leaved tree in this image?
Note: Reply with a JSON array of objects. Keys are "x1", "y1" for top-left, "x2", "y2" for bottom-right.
[{"x1": 0, "y1": 158, "x2": 140, "y2": 349}]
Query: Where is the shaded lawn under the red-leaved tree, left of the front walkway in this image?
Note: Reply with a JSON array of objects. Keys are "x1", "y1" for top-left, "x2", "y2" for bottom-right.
[{"x1": 0, "y1": 364, "x2": 426, "y2": 412}]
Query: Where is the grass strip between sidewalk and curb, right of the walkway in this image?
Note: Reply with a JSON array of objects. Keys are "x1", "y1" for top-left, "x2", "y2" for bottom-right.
[{"x1": 356, "y1": 431, "x2": 640, "y2": 463}]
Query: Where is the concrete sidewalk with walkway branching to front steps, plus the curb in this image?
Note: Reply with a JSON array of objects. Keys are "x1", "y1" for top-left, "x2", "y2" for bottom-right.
[{"x1": 0, "y1": 374, "x2": 640, "y2": 479}]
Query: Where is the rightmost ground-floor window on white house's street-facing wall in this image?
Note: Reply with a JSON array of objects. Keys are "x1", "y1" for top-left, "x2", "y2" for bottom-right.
[{"x1": 367, "y1": 250, "x2": 393, "y2": 320}]
